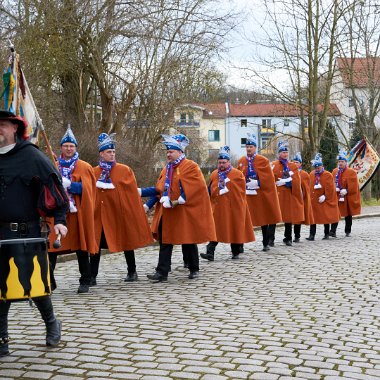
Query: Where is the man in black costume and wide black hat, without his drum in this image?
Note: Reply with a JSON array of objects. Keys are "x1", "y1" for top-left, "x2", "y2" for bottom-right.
[{"x1": 0, "y1": 111, "x2": 68, "y2": 356}]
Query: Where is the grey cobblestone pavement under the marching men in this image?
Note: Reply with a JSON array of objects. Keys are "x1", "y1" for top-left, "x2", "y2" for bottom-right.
[{"x1": 0, "y1": 217, "x2": 380, "y2": 380}]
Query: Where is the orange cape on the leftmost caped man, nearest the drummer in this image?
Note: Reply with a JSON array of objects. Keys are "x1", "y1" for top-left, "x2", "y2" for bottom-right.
[{"x1": 49, "y1": 160, "x2": 98, "y2": 254}]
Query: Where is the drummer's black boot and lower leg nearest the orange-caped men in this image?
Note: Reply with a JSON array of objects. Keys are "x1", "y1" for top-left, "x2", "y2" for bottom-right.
[{"x1": 33, "y1": 297, "x2": 62, "y2": 347}]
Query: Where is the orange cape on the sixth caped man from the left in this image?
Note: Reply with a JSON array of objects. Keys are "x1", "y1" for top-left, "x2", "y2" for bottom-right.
[{"x1": 272, "y1": 160, "x2": 305, "y2": 224}]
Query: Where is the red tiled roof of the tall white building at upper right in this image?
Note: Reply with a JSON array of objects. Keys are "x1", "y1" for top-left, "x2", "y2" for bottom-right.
[{"x1": 336, "y1": 57, "x2": 380, "y2": 88}]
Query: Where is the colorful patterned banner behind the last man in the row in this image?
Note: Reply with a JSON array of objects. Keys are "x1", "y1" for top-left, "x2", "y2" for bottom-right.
[{"x1": 347, "y1": 138, "x2": 380, "y2": 191}]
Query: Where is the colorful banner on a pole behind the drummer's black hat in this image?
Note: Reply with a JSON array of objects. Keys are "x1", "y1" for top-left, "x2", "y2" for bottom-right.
[{"x1": 2, "y1": 51, "x2": 42, "y2": 144}]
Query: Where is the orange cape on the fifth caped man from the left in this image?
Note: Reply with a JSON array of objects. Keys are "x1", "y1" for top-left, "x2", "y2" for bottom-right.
[{"x1": 237, "y1": 154, "x2": 282, "y2": 226}]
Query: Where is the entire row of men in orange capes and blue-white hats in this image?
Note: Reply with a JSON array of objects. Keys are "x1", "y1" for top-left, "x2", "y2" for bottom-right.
[{"x1": 49, "y1": 128, "x2": 360, "y2": 293}]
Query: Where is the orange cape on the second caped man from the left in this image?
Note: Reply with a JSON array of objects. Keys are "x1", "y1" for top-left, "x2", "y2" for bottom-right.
[{"x1": 94, "y1": 163, "x2": 153, "y2": 252}]
